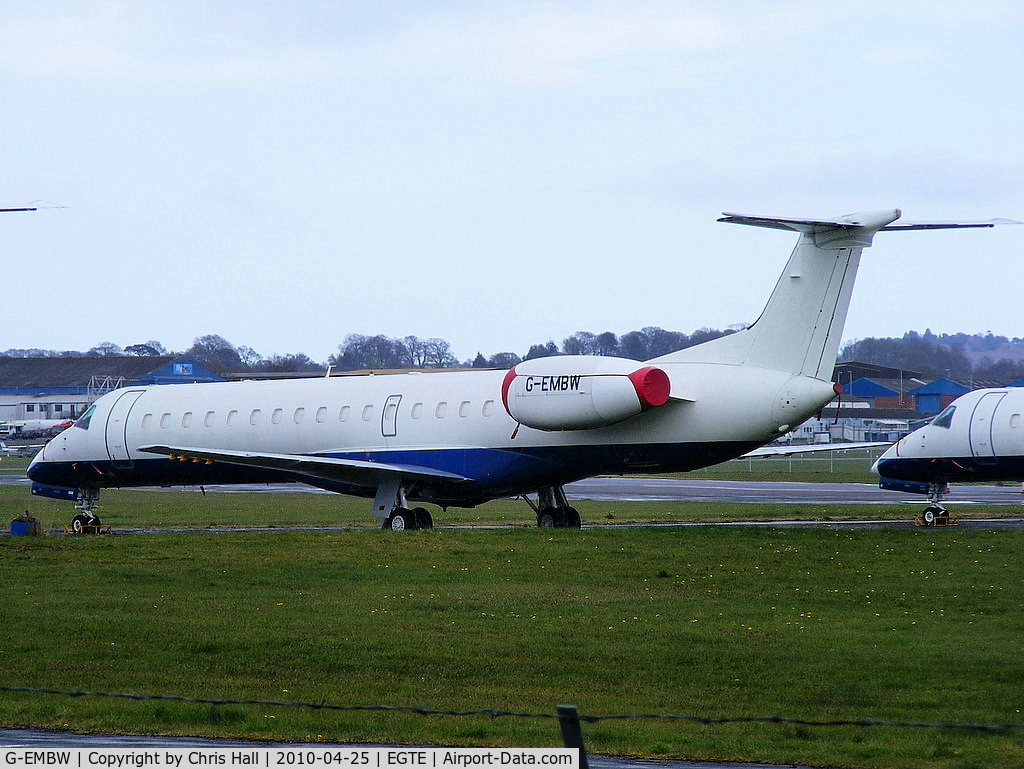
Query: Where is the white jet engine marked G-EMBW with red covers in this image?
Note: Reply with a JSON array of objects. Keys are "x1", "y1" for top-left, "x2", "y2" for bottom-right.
[{"x1": 502, "y1": 355, "x2": 671, "y2": 431}]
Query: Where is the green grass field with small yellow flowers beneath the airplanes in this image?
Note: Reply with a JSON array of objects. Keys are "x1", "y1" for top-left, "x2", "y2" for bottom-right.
[{"x1": 0, "y1": 456, "x2": 1024, "y2": 768}]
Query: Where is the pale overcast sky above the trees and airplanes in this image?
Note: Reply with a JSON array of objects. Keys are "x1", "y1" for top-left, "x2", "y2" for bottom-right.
[{"x1": 0, "y1": 0, "x2": 1024, "y2": 361}]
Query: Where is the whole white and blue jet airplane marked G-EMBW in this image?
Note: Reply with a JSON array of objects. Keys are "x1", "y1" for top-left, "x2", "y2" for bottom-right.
[{"x1": 28, "y1": 210, "x2": 1011, "y2": 530}]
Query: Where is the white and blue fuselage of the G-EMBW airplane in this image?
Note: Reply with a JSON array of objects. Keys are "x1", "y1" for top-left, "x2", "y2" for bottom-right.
[{"x1": 29, "y1": 362, "x2": 835, "y2": 507}]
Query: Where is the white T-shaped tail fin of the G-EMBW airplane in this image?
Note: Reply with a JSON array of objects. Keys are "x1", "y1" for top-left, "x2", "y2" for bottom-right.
[{"x1": 652, "y1": 209, "x2": 997, "y2": 381}]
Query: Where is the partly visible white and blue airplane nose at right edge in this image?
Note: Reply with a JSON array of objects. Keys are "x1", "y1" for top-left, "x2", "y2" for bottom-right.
[{"x1": 871, "y1": 387, "x2": 1024, "y2": 524}]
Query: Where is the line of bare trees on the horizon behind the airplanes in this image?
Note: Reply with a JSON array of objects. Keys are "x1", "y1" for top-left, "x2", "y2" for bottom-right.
[{"x1": 6, "y1": 327, "x2": 1024, "y2": 386}]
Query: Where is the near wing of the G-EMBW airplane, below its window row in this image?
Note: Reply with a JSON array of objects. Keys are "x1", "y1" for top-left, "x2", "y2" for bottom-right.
[{"x1": 138, "y1": 445, "x2": 469, "y2": 486}]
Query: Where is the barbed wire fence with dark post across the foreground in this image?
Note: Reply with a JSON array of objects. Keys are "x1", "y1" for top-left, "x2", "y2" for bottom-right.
[{"x1": 0, "y1": 686, "x2": 1024, "y2": 769}]
